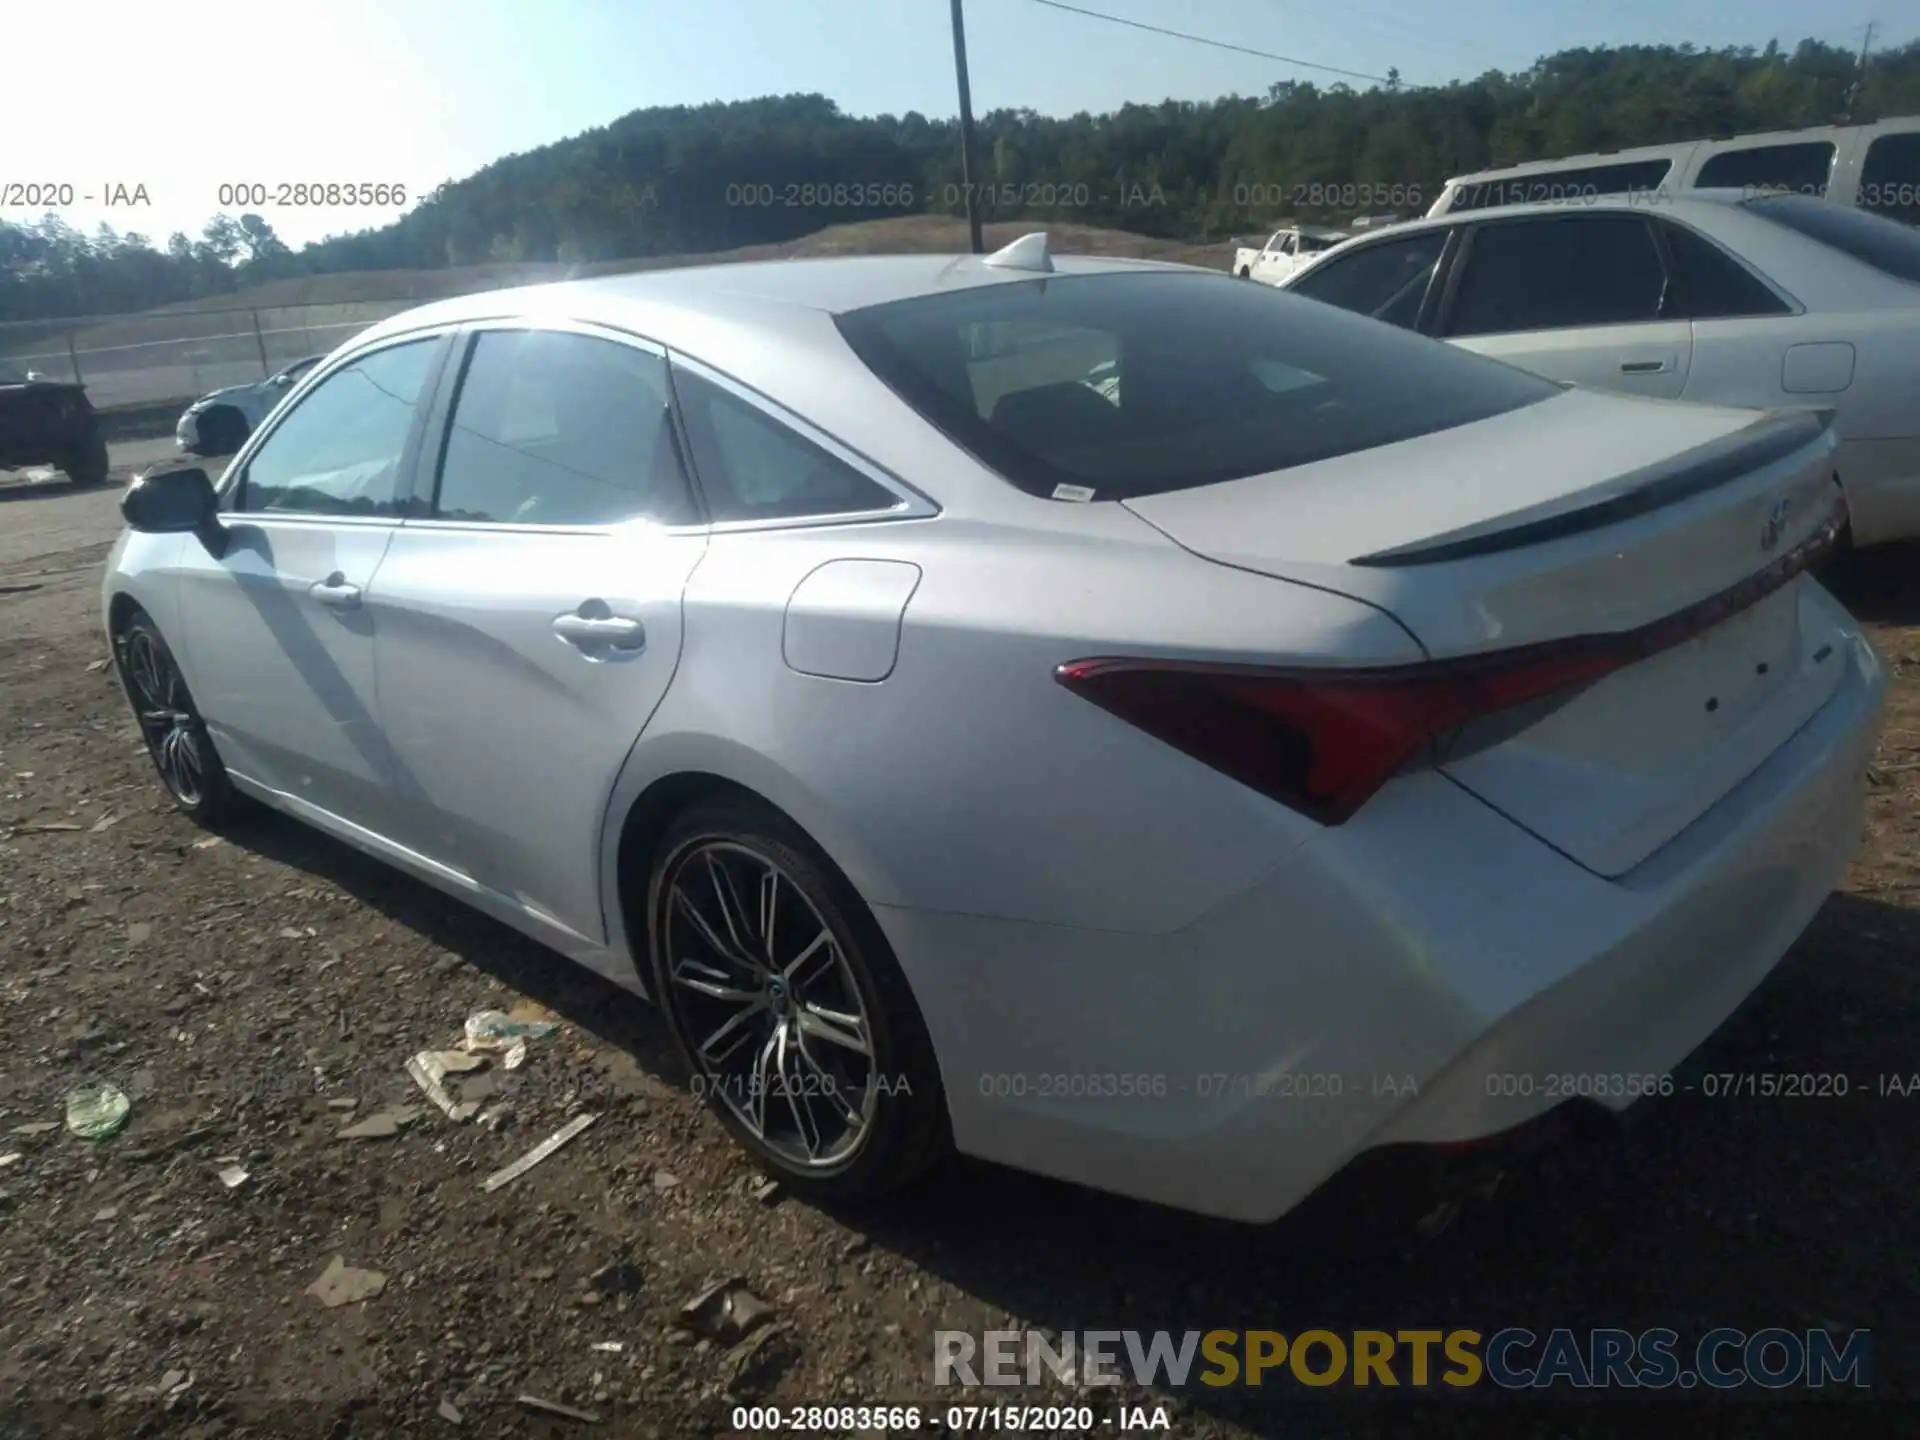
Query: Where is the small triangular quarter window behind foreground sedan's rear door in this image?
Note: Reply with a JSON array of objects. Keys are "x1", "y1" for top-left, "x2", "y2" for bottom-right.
[{"x1": 674, "y1": 367, "x2": 900, "y2": 522}]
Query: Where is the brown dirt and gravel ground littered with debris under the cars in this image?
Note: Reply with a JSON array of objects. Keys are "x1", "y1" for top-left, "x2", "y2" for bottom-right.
[{"x1": 0, "y1": 453, "x2": 1920, "y2": 1436}]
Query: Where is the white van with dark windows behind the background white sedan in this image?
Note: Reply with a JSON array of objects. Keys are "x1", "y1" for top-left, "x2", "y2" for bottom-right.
[{"x1": 1427, "y1": 115, "x2": 1920, "y2": 225}]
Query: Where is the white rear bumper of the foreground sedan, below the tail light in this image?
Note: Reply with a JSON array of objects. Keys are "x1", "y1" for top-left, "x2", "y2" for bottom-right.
[{"x1": 876, "y1": 601, "x2": 1885, "y2": 1221}]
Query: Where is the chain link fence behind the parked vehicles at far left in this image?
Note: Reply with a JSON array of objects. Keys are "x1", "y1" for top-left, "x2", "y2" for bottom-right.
[{"x1": 0, "y1": 298, "x2": 420, "y2": 411}]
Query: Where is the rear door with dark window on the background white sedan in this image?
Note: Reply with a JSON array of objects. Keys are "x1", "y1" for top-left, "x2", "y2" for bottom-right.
[{"x1": 1438, "y1": 211, "x2": 1693, "y2": 399}]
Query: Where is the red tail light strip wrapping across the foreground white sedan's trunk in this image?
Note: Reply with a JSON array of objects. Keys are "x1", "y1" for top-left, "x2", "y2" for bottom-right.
[{"x1": 1054, "y1": 499, "x2": 1847, "y2": 826}]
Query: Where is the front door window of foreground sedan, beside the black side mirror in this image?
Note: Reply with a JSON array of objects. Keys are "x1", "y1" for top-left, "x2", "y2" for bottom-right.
[{"x1": 234, "y1": 336, "x2": 442, "y2": 516}]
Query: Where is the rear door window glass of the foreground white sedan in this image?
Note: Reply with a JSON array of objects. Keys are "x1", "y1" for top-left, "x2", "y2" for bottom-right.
[{"x1": 432, "y1": 330, "x2": 693, "y2": 526}]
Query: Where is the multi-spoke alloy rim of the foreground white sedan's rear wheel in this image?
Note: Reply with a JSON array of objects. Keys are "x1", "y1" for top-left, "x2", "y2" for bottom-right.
[{"x1": 660, "y1": 839, "x2": 879, "y2": 1171}]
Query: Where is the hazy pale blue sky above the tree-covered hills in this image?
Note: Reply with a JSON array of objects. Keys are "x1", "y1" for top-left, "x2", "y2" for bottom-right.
[{"x1": 0, "y1": 0, "x2": 1920, "y2": 244}]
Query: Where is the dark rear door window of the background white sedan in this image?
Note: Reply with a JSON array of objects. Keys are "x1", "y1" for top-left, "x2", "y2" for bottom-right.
[{"x1": 1448, "y1": 215, "x2": 1667, "y2": 336}]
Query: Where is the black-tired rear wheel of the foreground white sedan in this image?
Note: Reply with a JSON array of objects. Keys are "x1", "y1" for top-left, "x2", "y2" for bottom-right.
[{"x1": 647, "y1": 797, "x2": 950, "y2": 1204}]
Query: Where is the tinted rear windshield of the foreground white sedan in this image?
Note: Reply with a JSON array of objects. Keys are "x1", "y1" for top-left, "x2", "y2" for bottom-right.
[{"x1": 839, "y1": 273, "x2": 1559, "y2": 499}]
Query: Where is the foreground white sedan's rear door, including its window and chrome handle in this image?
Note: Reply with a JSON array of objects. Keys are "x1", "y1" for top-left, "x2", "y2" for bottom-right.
[{"x1": 371, "y1": 323, "x2": 707, "y2": 948}]
